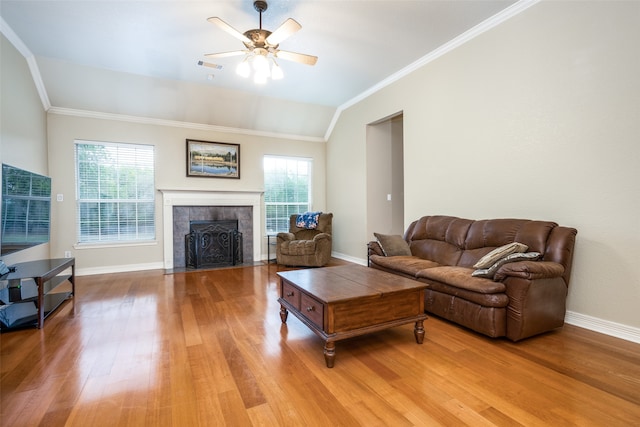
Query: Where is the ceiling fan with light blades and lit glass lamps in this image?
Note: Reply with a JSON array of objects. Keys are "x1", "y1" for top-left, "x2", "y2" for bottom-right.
[{"x1": 205, "y1": 0, "x2": 318, "y2": 83}]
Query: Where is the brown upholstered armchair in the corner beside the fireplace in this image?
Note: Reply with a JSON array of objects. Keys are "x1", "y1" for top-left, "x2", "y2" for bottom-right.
[{"x1": 276, "y1": 213, "x2": 333, "y2": 267}]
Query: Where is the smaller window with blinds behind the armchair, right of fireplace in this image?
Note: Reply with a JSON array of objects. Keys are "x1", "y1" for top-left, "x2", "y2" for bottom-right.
[{"x1": 264, "y1": 156, "x2": 311, "y2": 234}]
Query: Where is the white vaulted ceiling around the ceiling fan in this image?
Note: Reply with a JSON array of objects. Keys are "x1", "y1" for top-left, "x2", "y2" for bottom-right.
[{"x1": 0, "y1": 0, "x2": 515, "y2": 137}]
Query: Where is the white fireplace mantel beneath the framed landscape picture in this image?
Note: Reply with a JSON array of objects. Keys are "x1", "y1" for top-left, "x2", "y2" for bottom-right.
[{"x1": 160, "y1": 190, "x2": 263, "y2": 269}]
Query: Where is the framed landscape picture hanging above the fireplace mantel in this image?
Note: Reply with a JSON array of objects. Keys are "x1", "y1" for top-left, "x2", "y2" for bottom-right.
[{"x1": 187, "y1": 139, "x2": 240, "y2": 178}]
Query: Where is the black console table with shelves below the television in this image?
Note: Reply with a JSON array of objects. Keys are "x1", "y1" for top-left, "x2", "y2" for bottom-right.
[{"x1": 2, "y1": 258, "x2": 76, "y2": 329}]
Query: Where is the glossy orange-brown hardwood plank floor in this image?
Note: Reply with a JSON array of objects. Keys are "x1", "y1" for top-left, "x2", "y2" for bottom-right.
[{"x1": 0, "y1": 260, "x2": 640, "y2": 427}]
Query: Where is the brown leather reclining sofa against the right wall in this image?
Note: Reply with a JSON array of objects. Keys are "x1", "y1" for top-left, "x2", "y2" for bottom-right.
[{"x1": 368, "y1": 216, "x2": 577, "y2": 341}]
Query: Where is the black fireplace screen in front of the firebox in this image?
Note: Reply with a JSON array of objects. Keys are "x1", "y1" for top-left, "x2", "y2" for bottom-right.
[{"x1": 185, "y1": 220, "x2": 242, "y2": 268}]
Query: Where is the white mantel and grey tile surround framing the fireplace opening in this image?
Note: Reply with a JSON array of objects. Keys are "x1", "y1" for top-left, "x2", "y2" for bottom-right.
[{"x1": 160, "y1": 190, "x2": 262, "y2": 269}]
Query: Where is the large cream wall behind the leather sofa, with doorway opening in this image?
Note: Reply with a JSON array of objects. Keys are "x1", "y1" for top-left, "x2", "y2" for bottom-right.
[{"x1": 327, "y1": 1, "x2": 640, "y2": 328}]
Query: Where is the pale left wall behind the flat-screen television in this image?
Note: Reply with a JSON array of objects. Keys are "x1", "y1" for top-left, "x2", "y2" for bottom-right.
[{"x1": 0, "y1": 34, "x2": 49, "y2": 265}]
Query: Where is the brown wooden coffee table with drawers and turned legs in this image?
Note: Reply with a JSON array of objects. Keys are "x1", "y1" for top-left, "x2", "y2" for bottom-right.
[{"x1": 277, "y1": 265, "x2": 427, "y2": 368}]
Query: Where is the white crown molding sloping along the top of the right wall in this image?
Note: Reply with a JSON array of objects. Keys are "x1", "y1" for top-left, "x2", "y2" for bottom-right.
[{"x1": 324, "y1": 0, "x2": 540, "y2": 140}]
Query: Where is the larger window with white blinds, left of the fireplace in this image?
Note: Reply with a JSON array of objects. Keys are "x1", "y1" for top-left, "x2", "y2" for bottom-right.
[{"x1": 76, "y1": 141, "x2": 156, "y2": 243}]
